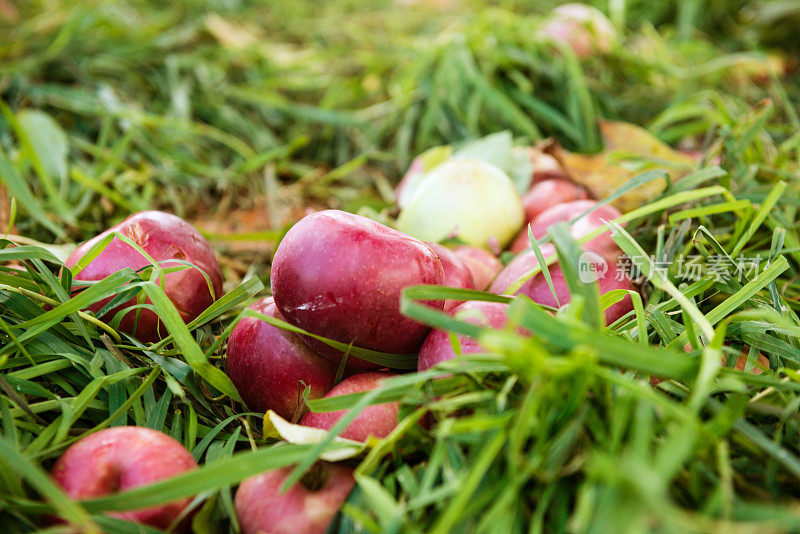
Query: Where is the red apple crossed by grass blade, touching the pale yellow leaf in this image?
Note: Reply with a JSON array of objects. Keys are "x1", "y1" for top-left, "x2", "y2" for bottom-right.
[{"x1": 300, "y1": 372, "x2": 400, "y2": 441}]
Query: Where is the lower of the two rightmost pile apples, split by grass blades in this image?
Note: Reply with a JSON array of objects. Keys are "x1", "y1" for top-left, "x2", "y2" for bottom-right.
[{"x1": 489, "y1": 247, "x2": 633, "y2": 324}]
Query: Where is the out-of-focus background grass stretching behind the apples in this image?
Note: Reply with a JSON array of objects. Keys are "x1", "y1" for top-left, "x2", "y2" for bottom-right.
[{"x1": 0, "y1": 0, "x2": 800, "y2": 246}]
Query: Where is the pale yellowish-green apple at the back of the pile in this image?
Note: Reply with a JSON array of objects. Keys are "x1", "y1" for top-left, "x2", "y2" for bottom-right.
[{"x1": 397, "y1": 159, "x2": 524, "y2": 250}]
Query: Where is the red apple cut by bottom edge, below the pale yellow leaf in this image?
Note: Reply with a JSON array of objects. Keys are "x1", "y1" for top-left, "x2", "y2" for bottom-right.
[{"x1": 234, "y1": 462, "x2": 355, "y2": 534}]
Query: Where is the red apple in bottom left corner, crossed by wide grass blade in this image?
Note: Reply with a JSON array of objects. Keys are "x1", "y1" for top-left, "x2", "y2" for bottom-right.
[{"x1": 52, "y1": 426, "x2": 197, "y2": 529}]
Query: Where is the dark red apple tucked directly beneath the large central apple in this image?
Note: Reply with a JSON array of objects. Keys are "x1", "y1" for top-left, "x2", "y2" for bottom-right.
[{"x1": 227, "y1": 297, "x2": 337, "y2": 420}]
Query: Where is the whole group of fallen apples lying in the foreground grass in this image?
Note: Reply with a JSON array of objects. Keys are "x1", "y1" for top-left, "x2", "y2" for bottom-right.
[{"x1": 52, "y1": 140, "x2": 632, "y2": 533}]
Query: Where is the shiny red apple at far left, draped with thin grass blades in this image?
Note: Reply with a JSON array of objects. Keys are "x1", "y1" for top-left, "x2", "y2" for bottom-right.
[{"x1": 64, "y1": 211, "x2": 222, "y2": 342}]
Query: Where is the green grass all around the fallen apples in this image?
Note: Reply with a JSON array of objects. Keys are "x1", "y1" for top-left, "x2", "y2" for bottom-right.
[{"x1": 0, "y1": 0, "x2": 800, "y2": 533}]
